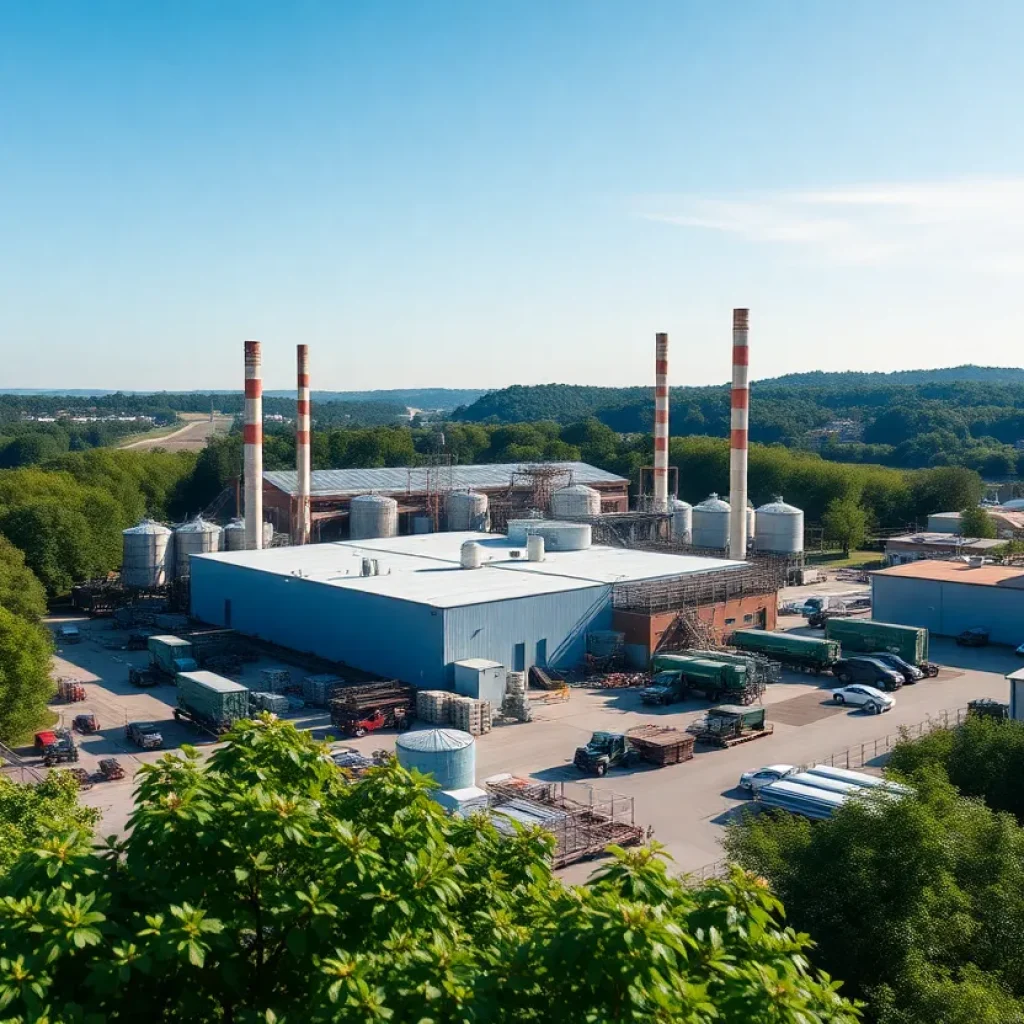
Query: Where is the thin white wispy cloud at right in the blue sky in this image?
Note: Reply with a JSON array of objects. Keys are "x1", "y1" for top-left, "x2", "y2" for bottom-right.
[{"x1": 641, "y1": 178, "x2": 1024, "y2": 274}]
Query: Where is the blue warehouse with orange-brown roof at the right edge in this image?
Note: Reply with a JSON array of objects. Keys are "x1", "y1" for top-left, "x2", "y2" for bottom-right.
[{"x1": 871, "y1": 561, "x2": 1024, "y2": 647}]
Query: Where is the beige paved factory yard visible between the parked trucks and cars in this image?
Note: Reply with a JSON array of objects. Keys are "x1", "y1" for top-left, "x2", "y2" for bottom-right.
[{"x1": 37, "y1": 606, "x2": 1020, "y2": 880}]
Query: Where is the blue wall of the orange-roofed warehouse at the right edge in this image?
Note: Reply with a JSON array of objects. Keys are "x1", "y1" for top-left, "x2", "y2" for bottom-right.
[{"x1": 871, "y1": 575, "x2": 1024, "y2": 647}]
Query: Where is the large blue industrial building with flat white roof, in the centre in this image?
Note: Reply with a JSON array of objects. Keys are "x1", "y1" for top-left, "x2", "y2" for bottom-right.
[{"x1": 191, "y1": 532, "x2": 742, "y2": 688}]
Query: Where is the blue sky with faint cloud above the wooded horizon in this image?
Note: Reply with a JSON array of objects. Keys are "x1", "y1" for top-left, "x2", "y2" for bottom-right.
[{"x1": 0, "y1": 0, "x2": 1024, "y2": 389}]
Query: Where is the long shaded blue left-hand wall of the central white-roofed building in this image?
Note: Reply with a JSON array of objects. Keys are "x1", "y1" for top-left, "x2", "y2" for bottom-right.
[{"x1": 191, "y1": 558, "x2": 446, "y2": 688}]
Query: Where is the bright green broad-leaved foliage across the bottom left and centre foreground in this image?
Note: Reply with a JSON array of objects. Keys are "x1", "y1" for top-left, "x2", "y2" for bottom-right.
[{"x1": 0, "y1": 720, "x2": 858, "y2": 1024}]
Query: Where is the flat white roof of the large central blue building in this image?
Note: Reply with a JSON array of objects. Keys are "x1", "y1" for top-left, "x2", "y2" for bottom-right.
[{"x1": 193, "y1": 532, "x2": 744, "y2": 608}]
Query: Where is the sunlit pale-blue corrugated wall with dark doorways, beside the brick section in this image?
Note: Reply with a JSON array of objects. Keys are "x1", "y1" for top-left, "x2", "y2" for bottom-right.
[{"x1": 444, "y1": 585, "x2": 611, "y2": 669}]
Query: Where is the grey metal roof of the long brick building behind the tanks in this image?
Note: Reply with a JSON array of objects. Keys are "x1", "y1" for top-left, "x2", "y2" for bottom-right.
[{"x1": 263, "y1": 462, "x2": 629, "y2": 497}]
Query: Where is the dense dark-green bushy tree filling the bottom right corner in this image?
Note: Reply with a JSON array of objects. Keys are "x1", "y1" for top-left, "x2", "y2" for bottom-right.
[{"x1": 727, "y1": 767, "x2": 1024, "y2": 1024}]
